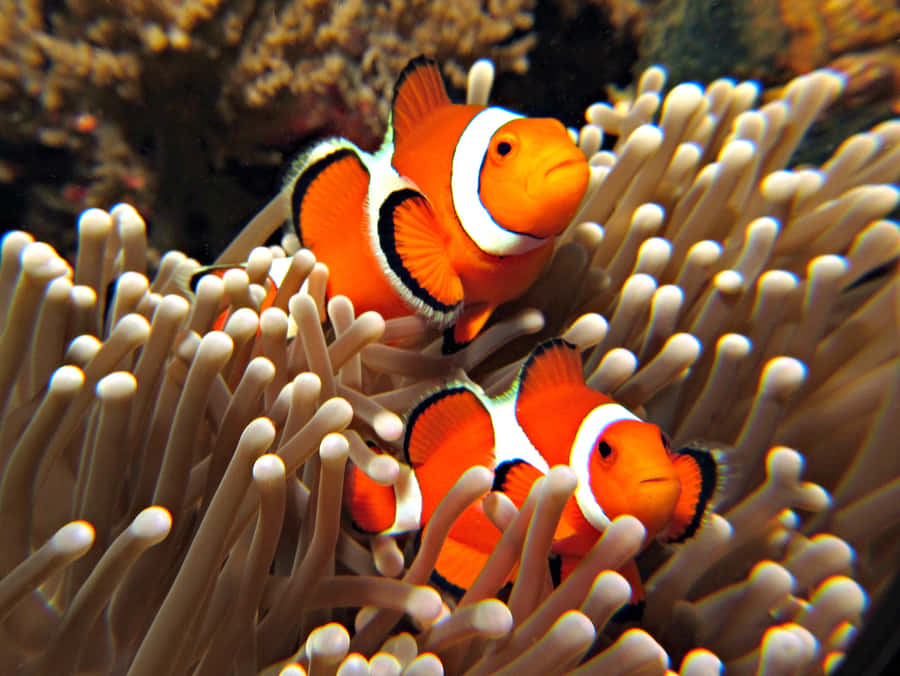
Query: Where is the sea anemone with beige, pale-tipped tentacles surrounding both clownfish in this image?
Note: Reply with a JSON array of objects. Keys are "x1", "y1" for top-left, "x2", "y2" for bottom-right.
[{"x1": 0, "y1": 63, "x2": 900, "y2": 676}]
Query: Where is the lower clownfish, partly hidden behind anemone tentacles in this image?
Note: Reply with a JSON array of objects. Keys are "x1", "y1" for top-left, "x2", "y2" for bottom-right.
[{"x1": 345, "y1": 339, "x2": 719, "y2": 612}]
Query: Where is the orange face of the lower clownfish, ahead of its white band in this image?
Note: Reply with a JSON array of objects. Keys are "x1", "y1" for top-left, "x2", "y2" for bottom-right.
[{"x1": 589, "y1": 420, "x2": 681, "y2": 537}]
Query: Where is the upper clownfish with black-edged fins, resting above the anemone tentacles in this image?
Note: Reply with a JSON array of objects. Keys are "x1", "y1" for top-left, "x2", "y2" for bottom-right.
[{"x1": 286, "y1": 56, "x2": 590, "y2": 349}]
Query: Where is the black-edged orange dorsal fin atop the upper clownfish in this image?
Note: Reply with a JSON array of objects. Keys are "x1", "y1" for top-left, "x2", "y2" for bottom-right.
[{"x1": 391, "y1": 55, "x2": 450, "y2": 145}]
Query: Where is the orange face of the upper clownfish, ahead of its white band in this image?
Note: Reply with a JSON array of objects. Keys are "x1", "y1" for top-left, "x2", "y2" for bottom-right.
[{"x1": 479, "y1": 117, "x2": 590, "y2": 239}]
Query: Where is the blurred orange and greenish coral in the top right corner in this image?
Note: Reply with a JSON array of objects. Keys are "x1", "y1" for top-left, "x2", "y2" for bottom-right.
[{"x1": 598, "y1": 0, "x2": 900, "y2": 164}]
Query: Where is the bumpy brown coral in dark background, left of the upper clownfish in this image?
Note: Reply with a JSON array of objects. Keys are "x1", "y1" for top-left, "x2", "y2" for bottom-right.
[{"x1": 0, "y1": 0, "x2": 534, "y2": 258}]
